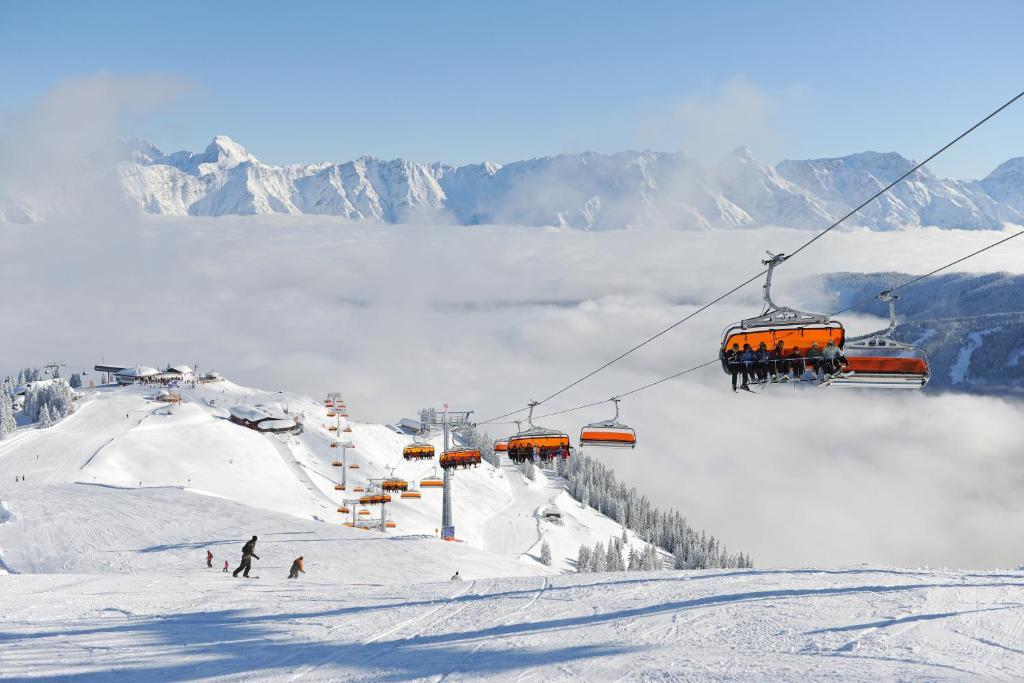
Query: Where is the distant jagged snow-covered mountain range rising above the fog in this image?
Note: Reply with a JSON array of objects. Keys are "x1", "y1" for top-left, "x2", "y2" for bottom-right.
[{"x1": 105, "y1": 135, "x2": 1024, "y2": 229}]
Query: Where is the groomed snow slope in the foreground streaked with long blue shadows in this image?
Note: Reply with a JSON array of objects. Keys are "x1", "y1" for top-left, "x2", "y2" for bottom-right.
[{"x1": 0, "y1": 558, "x2": 1024, "y2": 681}]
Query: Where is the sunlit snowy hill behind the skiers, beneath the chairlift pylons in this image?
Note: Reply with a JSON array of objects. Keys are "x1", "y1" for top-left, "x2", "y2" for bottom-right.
[{"x1": 0, "y1": 381, "x2": 643, "y2": 583}]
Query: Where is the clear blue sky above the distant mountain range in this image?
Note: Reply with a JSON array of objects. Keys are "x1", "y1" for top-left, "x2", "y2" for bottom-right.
[{"x1": 6, "y1": 1, "x2": 1024, "y2": 177}]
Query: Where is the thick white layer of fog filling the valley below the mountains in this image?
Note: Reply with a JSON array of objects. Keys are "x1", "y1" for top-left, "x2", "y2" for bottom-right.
[{"x1": 0, "y1": 217, "x2": 1024, "y2": 566}]
